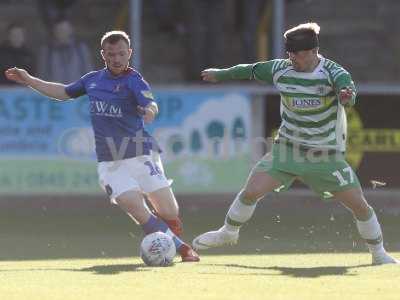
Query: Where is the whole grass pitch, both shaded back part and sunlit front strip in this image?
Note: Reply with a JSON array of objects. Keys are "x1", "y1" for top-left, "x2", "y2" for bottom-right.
[{"x1": 0, "y1": 204, "x2": 400, "y2": 300}]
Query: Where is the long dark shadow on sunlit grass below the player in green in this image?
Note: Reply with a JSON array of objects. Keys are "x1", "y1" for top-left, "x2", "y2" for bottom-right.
[{"x1": 205, "y1": 264, "x2": 372, "y2": 278}]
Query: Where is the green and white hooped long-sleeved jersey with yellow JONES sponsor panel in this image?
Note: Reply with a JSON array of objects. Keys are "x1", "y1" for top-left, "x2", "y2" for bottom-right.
[{"x1": 217, "y1": 56, "x2": 355, "y2": 152}]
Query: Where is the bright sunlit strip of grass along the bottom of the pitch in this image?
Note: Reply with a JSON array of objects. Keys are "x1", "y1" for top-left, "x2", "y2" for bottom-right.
[{"x1": 0, "y1": 253, "x2": 400, "y2": 300}]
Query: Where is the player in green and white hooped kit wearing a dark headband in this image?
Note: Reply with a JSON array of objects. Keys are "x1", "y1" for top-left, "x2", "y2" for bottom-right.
[{"x1": 193, "y1": 23, "x2": 399, "y2": 264}]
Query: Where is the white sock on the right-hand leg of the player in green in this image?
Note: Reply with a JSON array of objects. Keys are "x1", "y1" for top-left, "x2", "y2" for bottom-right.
[{"x1": 356, "y1": 208, "x2": 385, "y2": 254}]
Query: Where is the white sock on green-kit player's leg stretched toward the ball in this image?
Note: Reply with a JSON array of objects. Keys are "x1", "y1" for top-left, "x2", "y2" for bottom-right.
[{"x1": 224, "y1": 190, "x2": 258, "y2": 232}]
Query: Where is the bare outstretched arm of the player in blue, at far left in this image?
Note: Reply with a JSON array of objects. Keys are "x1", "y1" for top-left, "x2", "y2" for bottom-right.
[{"x1": 5, "y1": 67, "x2": 71, "y2": 101}]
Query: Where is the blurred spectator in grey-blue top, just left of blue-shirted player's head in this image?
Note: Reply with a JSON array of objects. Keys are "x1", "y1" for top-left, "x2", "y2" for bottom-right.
[{"x1": 38, "y1": 20, "x2": 93, "y2": 83}]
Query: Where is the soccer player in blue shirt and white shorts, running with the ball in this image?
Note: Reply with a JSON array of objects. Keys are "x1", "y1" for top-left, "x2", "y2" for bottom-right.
[{"x1": 5, "y1": 31, "x2": 200, "y2": 262}]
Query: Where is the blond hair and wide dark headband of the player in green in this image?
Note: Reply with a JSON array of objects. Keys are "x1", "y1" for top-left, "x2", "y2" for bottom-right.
[{"x1": 283, "y1": 23, "x2": 320, "y2": 52}]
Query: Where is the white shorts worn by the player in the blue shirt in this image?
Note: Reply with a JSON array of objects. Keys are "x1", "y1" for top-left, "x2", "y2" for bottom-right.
[{"x1": 97, "y1": 152, "x2": 171, "y2": 203}]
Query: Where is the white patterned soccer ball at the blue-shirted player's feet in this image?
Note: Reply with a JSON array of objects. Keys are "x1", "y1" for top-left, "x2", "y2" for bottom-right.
[{"x1": 140, "y1": 231, "x2": 176, "y2": 267}]
